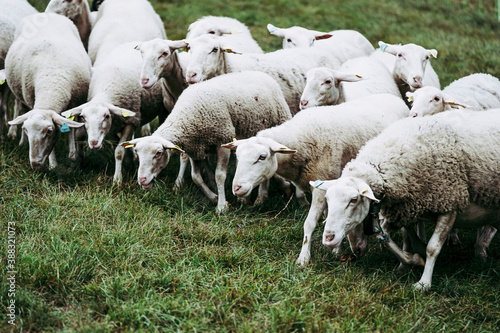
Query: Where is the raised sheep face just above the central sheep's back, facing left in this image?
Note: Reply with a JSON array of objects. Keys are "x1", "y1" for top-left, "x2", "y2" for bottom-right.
[{"x1": 186, "y1": 35, "x2": 229, "y2": 84}]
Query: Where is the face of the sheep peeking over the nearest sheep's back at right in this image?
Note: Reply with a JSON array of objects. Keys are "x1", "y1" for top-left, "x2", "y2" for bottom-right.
[{"x1": 407, "y1": 87, "x2": 450, "y2": 117}]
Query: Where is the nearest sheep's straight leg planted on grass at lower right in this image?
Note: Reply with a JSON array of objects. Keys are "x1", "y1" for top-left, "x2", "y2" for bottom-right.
[{"x1": 413, "y1": 212, "x2": 457, "y2": 290}]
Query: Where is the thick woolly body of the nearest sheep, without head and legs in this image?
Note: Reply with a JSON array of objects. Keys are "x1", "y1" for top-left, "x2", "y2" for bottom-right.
[{"x1": 342, "y1": 109, "x2": 500, "y2": 227}]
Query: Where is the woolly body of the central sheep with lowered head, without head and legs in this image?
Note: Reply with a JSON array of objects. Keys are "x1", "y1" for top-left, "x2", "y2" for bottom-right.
[{"x1": 153, "y1": 72, "x2": 292, "y2": 160}]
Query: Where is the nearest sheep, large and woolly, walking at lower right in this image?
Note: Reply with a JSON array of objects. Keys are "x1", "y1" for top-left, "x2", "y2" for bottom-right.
[{"x1": 319, "y1": 109, "x2": 500, "y2": 290}]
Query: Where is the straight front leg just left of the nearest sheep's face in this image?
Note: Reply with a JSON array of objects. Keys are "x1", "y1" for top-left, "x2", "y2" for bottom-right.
[{"x1": 295, "y1": 188, "x2": 326, "y2": 266}]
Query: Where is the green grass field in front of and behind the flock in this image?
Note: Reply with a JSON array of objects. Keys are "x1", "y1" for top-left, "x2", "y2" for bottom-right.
[{"x1": 0, "y1": 0, "x2": 500, "y2": 332}]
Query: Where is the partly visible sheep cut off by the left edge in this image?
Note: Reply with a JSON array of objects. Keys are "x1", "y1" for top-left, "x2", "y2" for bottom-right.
[{"x1": 0, "y1": 0, "x2": 38, "y2": 139}]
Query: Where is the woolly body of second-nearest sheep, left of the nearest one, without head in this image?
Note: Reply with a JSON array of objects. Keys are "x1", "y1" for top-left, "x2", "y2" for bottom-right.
[{"x1": 257, "y1": 94, "x2": 408, "y2": 192}]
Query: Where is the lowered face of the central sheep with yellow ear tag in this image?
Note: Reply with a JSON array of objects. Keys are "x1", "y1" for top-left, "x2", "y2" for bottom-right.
[{"x1": 126, "y1": 136, "x2": 179, "y2": 190}]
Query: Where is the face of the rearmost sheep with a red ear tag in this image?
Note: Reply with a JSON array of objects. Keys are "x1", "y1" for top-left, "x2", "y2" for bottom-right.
[{"x1": 267, "y1": 24, "x2": 332, "y2": 49}]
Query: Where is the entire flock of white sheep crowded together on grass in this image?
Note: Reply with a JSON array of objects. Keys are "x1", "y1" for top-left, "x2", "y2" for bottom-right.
[{"x1": 0, "y1": 0, "x2": 500, "y2": 290}]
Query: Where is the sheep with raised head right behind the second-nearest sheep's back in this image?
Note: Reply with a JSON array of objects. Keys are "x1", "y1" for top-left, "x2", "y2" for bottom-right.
[{"x1": 300, "y1": 57, "x2": 401, "y2": 110}]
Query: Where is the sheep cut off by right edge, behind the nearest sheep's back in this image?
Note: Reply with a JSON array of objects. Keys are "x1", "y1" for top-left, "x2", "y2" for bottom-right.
[{"x1": 406, "y1": 73, "x2": 500, "y2": 117}]
